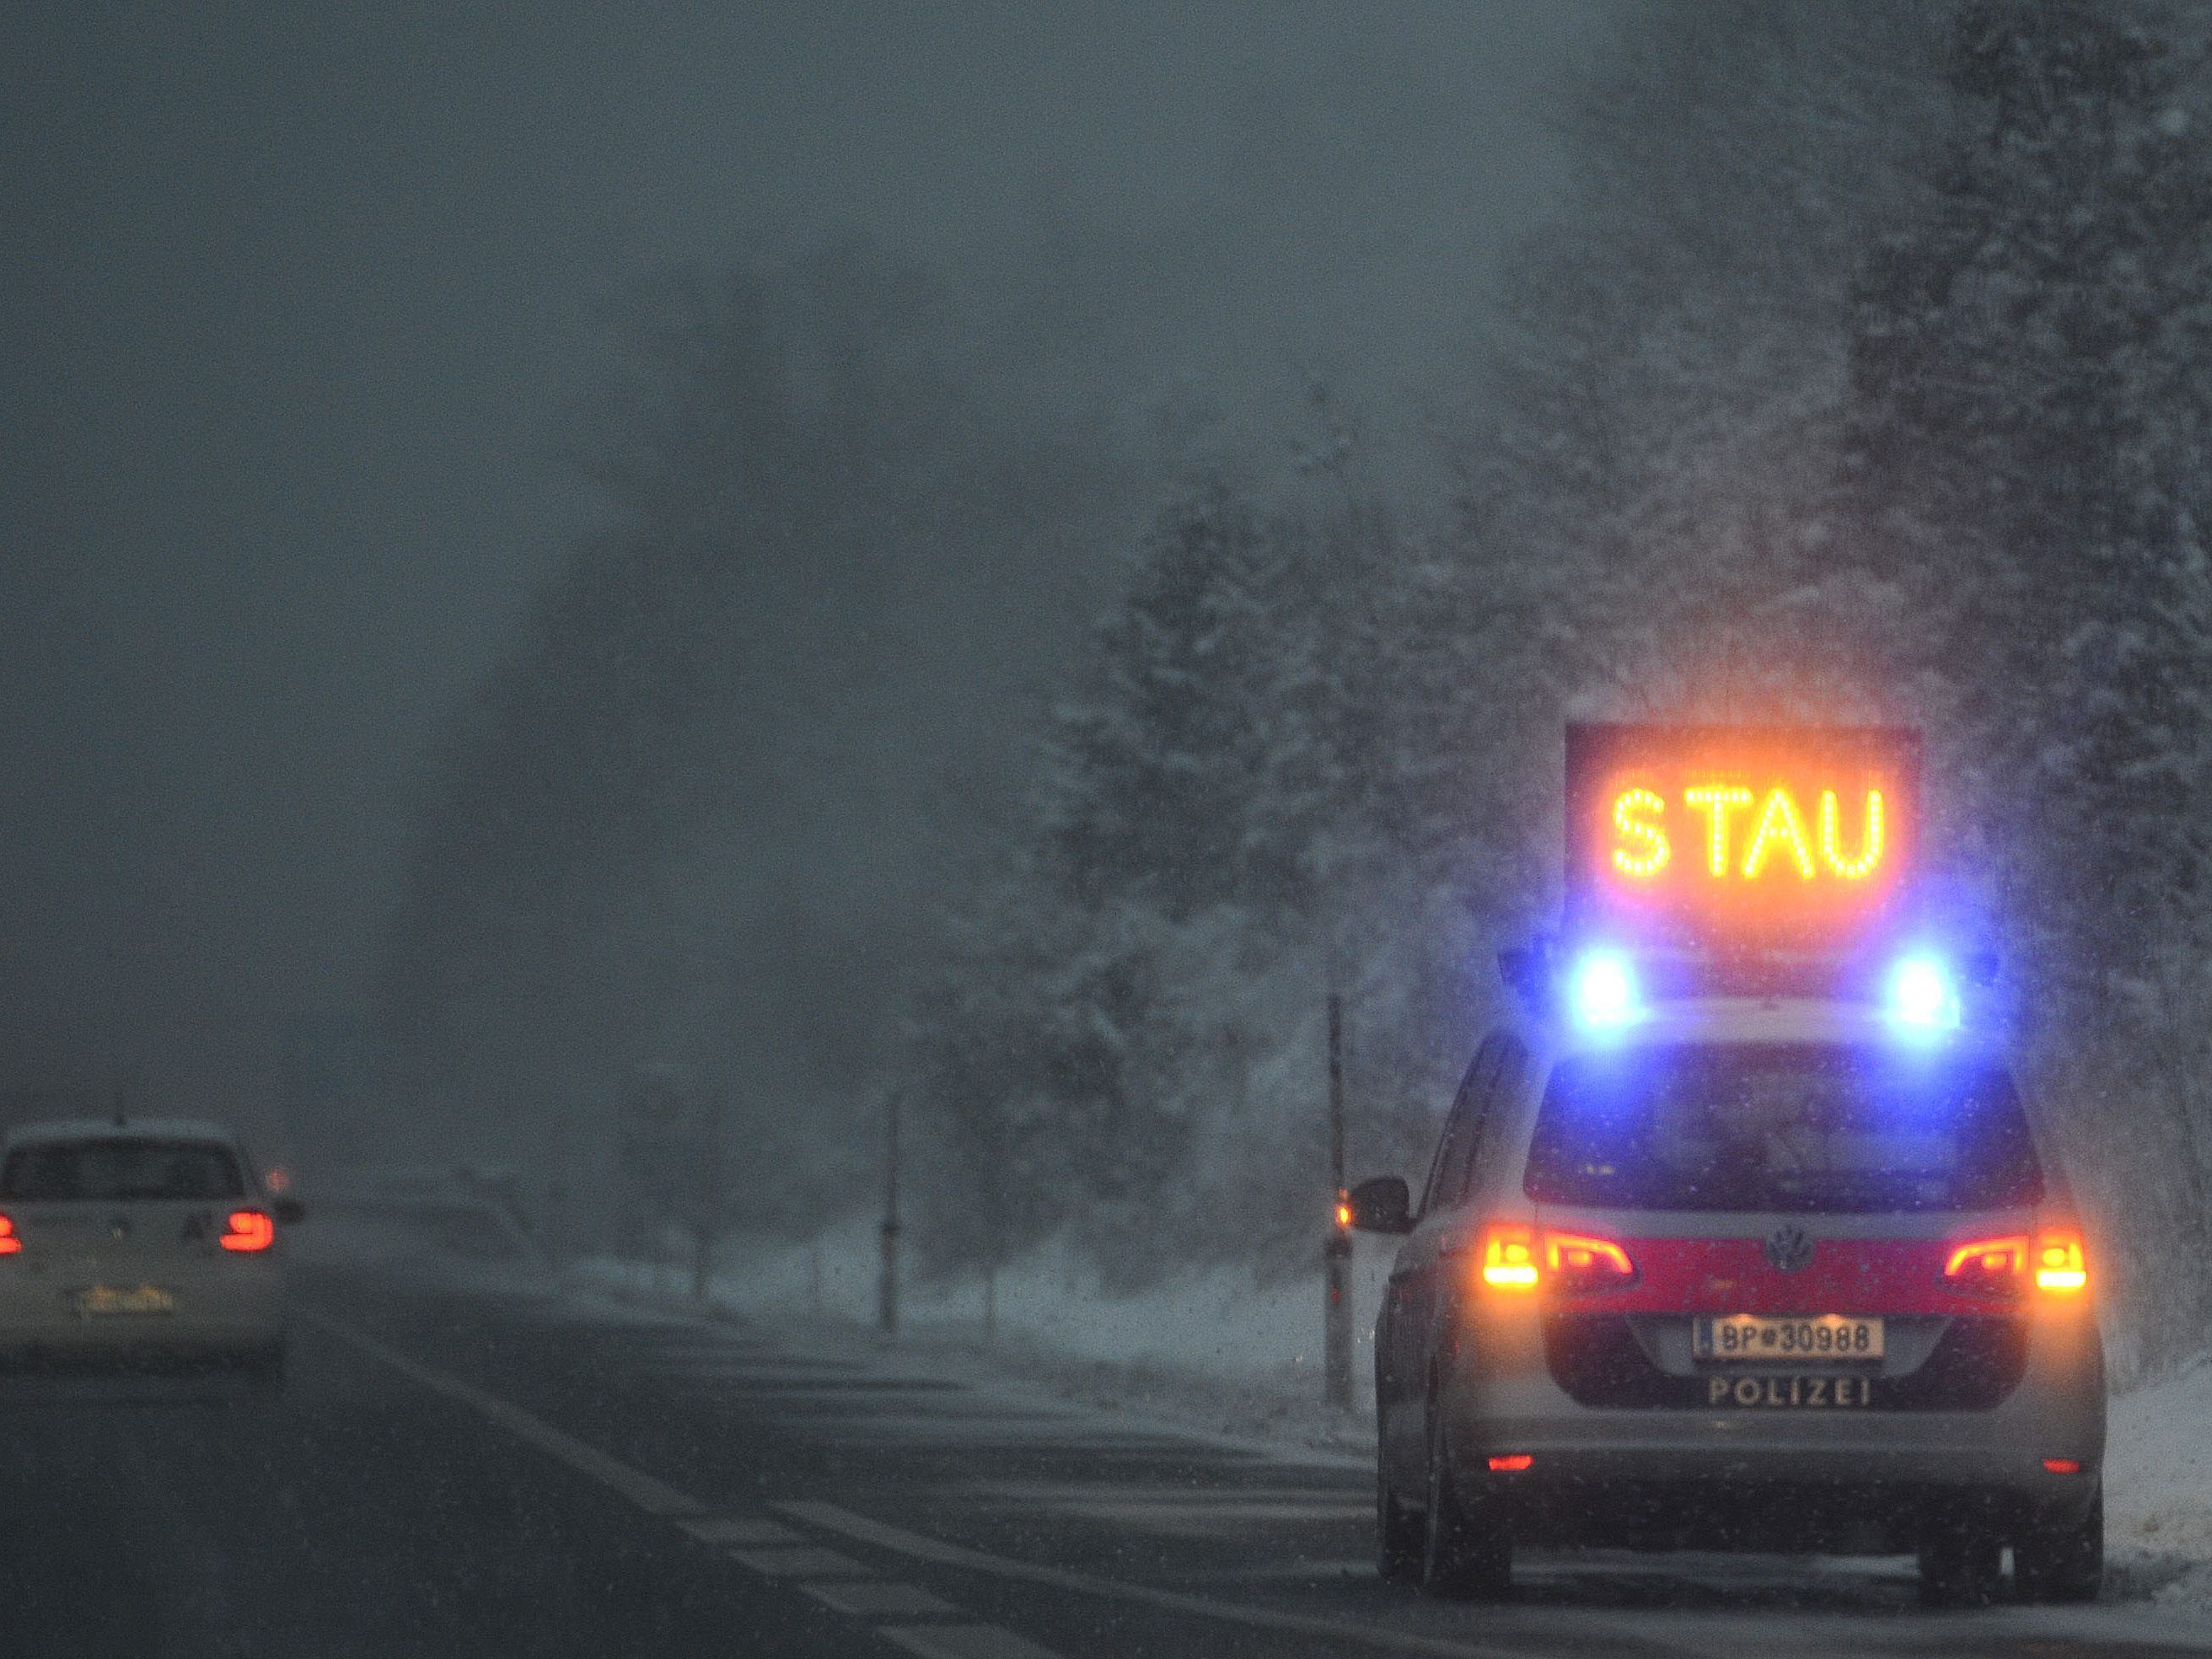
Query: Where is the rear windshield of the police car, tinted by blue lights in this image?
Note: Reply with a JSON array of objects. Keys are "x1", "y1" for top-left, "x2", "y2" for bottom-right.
[{"x1": 1527, "y1": 1044, "x2": 2044, "y2": 1212}]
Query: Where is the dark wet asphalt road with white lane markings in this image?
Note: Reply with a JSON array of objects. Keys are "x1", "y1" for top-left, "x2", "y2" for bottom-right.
[{"x1": 0, "y1": 1229, "x2": 2212, "y2": 1659}]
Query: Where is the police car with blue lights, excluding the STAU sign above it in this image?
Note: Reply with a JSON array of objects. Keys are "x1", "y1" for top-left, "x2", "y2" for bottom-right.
[{"x1": 1350, "y1": 951, "x2": 2106, "y2": 1606}]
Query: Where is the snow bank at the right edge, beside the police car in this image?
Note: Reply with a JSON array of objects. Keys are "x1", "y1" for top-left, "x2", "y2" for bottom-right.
[{"x1": 2103, "y1": 1354, "x2": 2212, "y2": 1610}]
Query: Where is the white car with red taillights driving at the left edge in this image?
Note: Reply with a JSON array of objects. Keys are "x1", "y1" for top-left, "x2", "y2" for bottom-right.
[{"x1": 0, "y1": 1117, "x2": 303, "y2": 1387}]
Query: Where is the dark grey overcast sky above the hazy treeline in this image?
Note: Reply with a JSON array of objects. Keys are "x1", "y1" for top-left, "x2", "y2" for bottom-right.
[{"x1": 0, "y1": 0, "x2": 1595, "y2": 1119}]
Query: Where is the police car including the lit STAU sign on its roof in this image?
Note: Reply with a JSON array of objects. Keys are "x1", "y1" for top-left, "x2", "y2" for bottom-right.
[{"x1": 1350, "y1": 727, "x2": 2106, "y2": 1603}]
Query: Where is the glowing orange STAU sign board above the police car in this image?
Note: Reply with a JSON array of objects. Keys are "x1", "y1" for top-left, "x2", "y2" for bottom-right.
[{"x1": 1566, "y1": 726, "x2": 1920, "y2": 944}]
